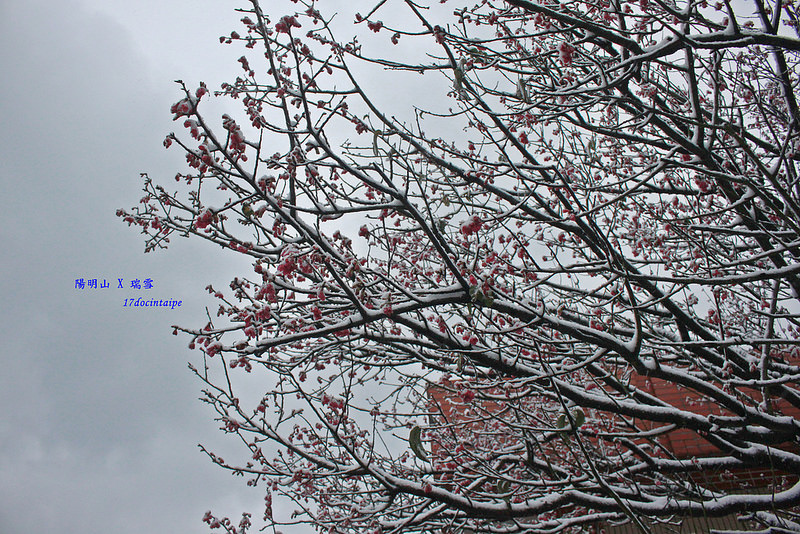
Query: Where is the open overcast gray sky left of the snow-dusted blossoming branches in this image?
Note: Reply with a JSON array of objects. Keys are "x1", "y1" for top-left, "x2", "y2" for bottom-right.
[{"x1": 0, "y1": 0, "x2": 270, "y2": 534}]
